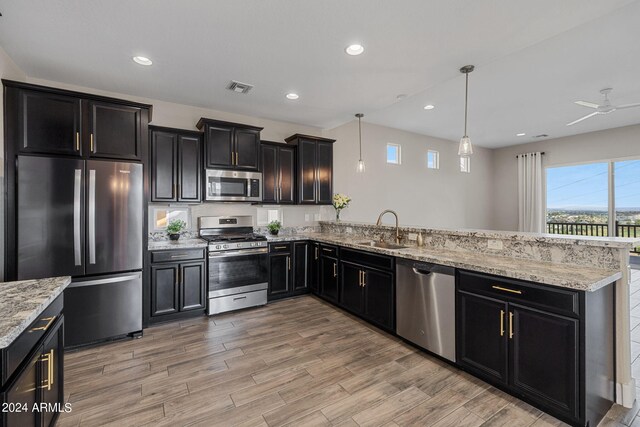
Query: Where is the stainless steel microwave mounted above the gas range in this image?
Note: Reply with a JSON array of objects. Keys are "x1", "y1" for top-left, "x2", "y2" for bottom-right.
[{"x1": 205, "y1": 169, "x2": 262, "y2": 202}]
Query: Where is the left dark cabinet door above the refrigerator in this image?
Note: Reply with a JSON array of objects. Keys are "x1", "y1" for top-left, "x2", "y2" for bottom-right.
[{"x1": 17, "y1": 90, "x2": 82, "y2": 156}]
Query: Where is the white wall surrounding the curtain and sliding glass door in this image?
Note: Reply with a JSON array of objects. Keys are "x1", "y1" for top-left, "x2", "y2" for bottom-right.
[{"x1": 491, "y1": 125, "x2": 640, "y2": 230}]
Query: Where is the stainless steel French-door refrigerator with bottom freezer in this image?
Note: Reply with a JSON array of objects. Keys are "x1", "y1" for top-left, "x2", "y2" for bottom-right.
[{"x1": 16, "y1": 156, "x2": 144, "y2": 347}]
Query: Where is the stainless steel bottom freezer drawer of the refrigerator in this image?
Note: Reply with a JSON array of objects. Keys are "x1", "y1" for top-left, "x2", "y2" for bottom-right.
[{"x1": 64, "y1": 272, "x2": 142, "y2": 348}]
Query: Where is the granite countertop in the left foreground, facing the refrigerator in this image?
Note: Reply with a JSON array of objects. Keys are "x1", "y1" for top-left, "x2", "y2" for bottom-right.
[{"x1": 0, "y1": 276, "x2": 71, "y2": 349}]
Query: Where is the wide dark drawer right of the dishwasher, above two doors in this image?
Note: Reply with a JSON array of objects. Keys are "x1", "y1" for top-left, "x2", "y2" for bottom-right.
[{"x1": 458, "y1": 270, "x2": 580, "y2": 316}]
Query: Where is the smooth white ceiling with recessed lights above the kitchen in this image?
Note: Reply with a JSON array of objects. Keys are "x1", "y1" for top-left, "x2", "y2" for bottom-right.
[{"x1": 0, "y1": 0, "x2": 640, "y2": 147}]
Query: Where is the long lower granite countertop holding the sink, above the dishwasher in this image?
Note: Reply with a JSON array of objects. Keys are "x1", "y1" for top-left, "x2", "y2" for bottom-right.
[{"x1": 267, "y1": 233, "x2": 622, "y2": 292}]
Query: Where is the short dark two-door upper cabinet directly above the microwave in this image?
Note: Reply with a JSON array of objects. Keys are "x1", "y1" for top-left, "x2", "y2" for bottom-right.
[{"x1": 196, "y1": 117, "x2": 262, "y2": 171}]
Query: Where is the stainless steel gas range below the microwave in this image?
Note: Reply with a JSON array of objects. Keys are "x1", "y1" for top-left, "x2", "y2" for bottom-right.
[{"x1": 198, "y1": 216, "x2": 269, "y2": 315}]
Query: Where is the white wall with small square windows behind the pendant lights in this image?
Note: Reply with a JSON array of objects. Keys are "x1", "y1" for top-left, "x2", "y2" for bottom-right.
[{"x1": 323, "y1": 120, "x2": 492, "y2": 228}]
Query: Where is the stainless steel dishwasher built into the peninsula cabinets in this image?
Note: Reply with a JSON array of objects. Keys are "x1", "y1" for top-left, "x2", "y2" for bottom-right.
[{"x1": 396, "y1": 258, "x2": 456, "y2": 362}]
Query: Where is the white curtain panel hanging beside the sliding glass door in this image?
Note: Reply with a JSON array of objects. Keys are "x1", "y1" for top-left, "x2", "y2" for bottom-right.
[{"x1": 518, "y1": 153, "x2": 544, "y2": 233}]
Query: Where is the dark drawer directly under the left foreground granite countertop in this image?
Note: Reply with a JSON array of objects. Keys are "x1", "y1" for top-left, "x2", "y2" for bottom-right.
[{"x1": 2, "y1": 294, "x2": 63, "y2": 384}]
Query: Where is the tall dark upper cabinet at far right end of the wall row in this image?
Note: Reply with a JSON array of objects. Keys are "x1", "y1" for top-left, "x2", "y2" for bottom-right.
[{"x1": 285, "y1": 134, "x2": 335, "y2": 205}]
